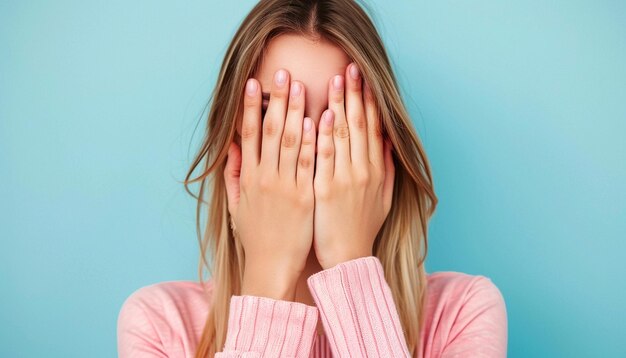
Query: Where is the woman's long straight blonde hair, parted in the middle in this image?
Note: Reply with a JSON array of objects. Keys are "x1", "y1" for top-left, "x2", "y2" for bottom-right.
[{"x1": 184, "y1": 0, "x2": 437, "y2": 357}]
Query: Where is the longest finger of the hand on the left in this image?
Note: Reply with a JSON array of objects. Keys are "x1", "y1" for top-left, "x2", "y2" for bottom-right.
[{"x1": 260, "y1": 69, "x2": 289, "y2": 170}]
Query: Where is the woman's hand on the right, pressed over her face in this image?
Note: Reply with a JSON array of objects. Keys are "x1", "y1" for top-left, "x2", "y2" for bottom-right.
[{"x1": 313, "y1": 63, "x2": 395, "y2": 269}]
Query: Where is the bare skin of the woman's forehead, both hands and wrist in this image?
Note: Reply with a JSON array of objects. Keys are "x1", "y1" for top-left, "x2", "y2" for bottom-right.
[{"x1": 225, "y1": 34, "x2": 395, "y2": 332}]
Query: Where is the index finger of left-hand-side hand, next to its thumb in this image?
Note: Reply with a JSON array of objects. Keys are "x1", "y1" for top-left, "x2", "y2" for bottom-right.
[{"x1": 241, "y1": 78, "x2": 261, "y2": 172}]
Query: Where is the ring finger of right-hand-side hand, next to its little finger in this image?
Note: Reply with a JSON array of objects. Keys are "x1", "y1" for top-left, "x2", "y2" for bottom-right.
[{"x1": 328, "y1": 75, "x2": 351, "y2": 172}]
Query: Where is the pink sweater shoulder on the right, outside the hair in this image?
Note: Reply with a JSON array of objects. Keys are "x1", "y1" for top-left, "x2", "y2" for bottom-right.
[{"x1": 422, "y1": 271, "x2": 507, "y2": 357}]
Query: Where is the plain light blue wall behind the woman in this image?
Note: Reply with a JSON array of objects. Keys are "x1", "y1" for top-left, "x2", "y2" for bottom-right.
[{"x1": 0, "y1": 0, "x2": 626, "y2": 357}]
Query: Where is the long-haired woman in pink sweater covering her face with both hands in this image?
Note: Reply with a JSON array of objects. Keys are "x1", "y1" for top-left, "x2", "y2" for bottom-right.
[{"x1": 118, "y1": 0, "x2": 507, "y2": 358}]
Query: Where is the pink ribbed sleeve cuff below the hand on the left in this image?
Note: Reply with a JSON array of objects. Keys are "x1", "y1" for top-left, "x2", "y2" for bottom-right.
[{"x1": 215, "y1": 295, "x2": 318, "y2": 358}]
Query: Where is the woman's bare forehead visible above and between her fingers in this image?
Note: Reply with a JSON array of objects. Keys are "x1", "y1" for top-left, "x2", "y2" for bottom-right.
[{"x1": 237, "y1": 34, "x2": 351, "y2": 138}]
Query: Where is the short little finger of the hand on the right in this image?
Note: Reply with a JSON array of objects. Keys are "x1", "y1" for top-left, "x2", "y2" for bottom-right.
[{"x1": 315, "y1": 109, "x2": 335, "y2": 181}]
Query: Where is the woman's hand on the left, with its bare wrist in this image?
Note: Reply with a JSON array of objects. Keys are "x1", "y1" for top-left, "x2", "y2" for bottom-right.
[{"x1": 224, "y1": 70, "x2": 316, "y2": 300}]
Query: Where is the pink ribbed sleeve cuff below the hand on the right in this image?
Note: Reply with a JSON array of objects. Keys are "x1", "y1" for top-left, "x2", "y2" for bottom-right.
[{"x1": 307, "y1": 256, "x2": 410, "y2": 357}]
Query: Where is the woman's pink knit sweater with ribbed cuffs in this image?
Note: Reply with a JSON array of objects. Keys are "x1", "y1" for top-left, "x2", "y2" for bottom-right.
[{"x1": 117, "y1": 256, "x2": 507, "y2": 358}]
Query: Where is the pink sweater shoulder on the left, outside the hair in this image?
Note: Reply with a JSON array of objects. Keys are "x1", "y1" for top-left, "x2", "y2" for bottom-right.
[{"x1": 117, "y1": 281, "x2": 213, "y2": 350}]
